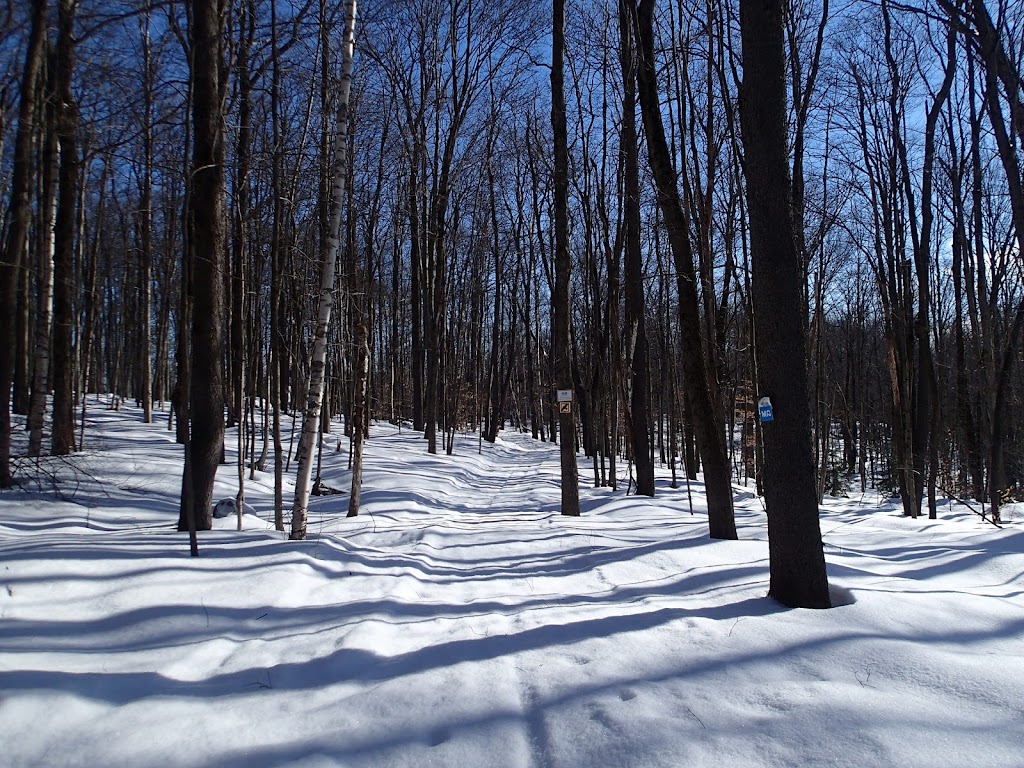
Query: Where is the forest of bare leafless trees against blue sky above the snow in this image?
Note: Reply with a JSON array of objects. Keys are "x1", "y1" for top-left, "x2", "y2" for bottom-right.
[{"x1": 0, "y1": 0, "x2": 1024, "y2": 565}]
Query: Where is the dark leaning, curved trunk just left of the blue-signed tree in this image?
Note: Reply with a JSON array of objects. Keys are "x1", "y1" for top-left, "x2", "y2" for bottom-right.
[{"x1": 636, "y1": 0, "x2": 736, "y2": 539}]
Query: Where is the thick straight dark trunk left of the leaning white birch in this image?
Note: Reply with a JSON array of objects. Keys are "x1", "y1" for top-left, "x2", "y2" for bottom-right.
[{"x1": 178, "y1": 0, "x2": 226, "y2": 530}]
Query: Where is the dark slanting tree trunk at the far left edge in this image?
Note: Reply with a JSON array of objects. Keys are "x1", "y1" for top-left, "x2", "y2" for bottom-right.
[{"x1": 0, "y1": 0, "x2": 46, "y2": 487}]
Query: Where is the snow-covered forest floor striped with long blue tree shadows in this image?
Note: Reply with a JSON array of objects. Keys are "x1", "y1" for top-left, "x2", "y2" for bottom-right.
[{"x1": 0, "y1": 402, "x2": 1024, "y2": 768}]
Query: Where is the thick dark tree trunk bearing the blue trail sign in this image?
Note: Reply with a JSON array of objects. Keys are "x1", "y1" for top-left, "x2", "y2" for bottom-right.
[{"x1": 739, "y1": 0, "x2": 831, "y2": 608}]
